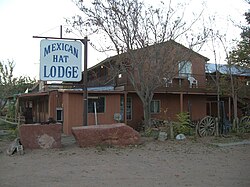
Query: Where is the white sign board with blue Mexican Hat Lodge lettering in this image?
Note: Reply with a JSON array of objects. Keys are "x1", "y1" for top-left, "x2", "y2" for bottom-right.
[{"x1": 40, "y1": 39, "x2": 82, "y2": 82}]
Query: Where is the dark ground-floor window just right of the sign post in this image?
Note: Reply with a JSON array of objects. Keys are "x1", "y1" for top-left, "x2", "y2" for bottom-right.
[{"x1": 88, "y1": 97, "x2": 105, "y2": 113}]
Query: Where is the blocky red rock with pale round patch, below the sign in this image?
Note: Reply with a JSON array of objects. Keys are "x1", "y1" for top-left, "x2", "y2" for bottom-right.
[{"x1": 20, "y1": 123, "x2": 62, "y2": 149}]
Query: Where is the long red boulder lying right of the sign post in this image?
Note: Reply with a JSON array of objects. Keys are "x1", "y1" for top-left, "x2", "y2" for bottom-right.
[{"x1": 72, "y1": 123, "x2": 140, "y2": 147}]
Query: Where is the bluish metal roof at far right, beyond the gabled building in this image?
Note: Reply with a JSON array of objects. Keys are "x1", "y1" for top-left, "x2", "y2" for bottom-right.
[{"x1": 205, "y1": 63, "x2": 250, "y2": 77}]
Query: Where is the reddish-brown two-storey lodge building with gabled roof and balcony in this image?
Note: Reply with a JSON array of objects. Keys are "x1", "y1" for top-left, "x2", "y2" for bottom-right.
[{"x1": 18, "y1": 41, "x2": 250, "y2": 134}]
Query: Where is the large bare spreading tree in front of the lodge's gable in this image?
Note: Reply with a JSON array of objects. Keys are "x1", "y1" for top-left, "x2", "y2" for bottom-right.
[{"x1": 68, "y1": 0, "x2": 207, "y2": 126}]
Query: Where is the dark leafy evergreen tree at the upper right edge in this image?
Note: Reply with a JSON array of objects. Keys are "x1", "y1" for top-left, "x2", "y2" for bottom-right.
[{"x1": 229, "y1": 1, "x2": 250, "y2": 67}]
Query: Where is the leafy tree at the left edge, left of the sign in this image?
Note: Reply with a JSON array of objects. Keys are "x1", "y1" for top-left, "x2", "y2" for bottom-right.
[{"x1": 0, "y1": 61, "x2": 35, "y2": 115}]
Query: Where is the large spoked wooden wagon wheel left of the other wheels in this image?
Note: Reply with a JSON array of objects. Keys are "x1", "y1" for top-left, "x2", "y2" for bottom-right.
[{"x1": 198, "y1": 116, "x2": 215, "y2": 136}]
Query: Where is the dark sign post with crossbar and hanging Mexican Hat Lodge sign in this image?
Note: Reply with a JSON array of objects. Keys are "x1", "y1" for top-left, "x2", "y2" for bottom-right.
[{"x1": 33, "y1": 35, "x2": 89, "y2": 126}]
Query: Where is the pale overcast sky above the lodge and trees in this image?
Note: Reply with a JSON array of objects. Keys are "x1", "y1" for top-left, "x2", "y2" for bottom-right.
[{"x1": 0, "y1": 0, "x2": 250, "y2": 80}]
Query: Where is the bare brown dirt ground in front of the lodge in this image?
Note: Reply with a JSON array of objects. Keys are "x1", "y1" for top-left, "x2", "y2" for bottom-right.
[{"x1": 0, "y1": 135, "x2": 250, "y2": 187}]
